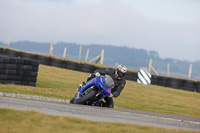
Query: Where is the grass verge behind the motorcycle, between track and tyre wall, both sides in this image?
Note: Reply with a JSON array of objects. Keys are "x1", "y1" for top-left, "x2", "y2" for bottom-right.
[{"x1": 0, "y1": 65, "x2": 200, "y2": 117}]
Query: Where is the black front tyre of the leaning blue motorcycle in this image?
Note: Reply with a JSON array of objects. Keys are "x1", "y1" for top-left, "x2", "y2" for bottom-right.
[{"x1": 75, "y1": 89, "x2": 97, "y2": 104}]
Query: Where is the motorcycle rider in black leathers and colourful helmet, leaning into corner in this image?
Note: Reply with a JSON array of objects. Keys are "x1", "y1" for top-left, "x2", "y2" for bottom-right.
[{"x1": 87, "y1": 65, "x2": 127, "y2": 108}]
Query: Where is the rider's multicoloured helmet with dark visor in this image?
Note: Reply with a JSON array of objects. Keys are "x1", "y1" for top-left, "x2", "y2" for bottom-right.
[{"x1": 115, "y1": 65, "x2": 127, "y2": 79}]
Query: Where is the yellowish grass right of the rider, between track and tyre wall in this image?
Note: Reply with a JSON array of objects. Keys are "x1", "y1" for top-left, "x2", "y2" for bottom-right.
[{"x1": 115, "y1": 82, "x2": 200, "y2": 117}]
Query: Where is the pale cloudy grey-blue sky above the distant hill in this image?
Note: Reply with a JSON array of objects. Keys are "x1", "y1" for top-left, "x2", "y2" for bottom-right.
[{"x1": 0, "y1": 0, "x2": 200, "y2": 61}]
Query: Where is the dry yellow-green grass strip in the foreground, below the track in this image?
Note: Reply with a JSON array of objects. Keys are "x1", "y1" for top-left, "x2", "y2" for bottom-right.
[{"x1": 0, "y1": 109, "x2": 197, "y2": 133}]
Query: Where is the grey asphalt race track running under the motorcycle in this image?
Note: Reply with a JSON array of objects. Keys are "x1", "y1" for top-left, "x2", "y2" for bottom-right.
[{"x1": 0, "y1": 97, "x2": 200, "y2": 131}]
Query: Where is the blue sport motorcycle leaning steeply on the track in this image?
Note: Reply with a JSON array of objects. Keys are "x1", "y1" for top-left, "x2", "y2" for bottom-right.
[{"x1": 72, "y1": 75, "x2": 114, "y2": 105}]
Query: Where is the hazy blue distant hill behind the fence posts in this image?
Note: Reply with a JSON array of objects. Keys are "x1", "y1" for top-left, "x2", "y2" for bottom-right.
[{"x1": 0, "y1": 41, "x2": 200, "y2": 80}]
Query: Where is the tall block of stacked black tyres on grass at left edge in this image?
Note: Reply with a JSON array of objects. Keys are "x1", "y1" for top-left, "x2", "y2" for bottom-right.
[{"x1": 0, "y1": 55, "x2": 39, "y2": 86}]
